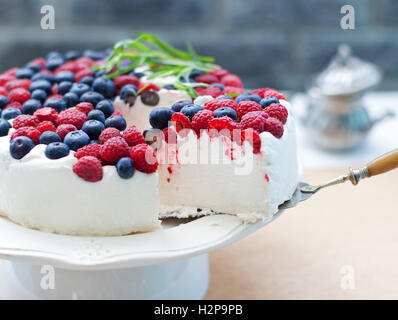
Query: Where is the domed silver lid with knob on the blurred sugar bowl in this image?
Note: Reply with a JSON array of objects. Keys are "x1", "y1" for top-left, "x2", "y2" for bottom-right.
[{"x1": 310, "y1": 44, "x2": 382, "y2": 95}]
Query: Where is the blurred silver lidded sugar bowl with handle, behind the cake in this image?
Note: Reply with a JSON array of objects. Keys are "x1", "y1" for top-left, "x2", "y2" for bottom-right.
[{"x1": 303, "y1": 44, "x2": 391, "y2": 150}]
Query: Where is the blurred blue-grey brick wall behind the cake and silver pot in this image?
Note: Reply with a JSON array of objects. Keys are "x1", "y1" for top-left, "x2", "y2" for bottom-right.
[{"x1": 0, "y1": 0, "x2": 398, "y2": 90}]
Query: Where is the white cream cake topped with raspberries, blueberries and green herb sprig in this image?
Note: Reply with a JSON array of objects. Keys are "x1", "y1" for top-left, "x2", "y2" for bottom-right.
[{"x1": 0, "y1": 34, "x2": 299, "y2": 236}]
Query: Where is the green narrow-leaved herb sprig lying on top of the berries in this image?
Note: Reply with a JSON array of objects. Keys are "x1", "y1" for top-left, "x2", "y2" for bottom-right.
[{"x1": 97, "y1": 32, "x2": 219, "y2": 98}]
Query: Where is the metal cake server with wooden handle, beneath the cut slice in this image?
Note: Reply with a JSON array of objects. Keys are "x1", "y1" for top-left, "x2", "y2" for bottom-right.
[{"x1": 279, "y1": 149, "x2": 398, "y2": 209}]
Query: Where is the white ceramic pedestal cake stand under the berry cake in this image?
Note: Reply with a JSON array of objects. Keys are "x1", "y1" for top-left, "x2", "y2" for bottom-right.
[{"x1": 0, "y1": 210, "x2": 283, "y2": 299}]
